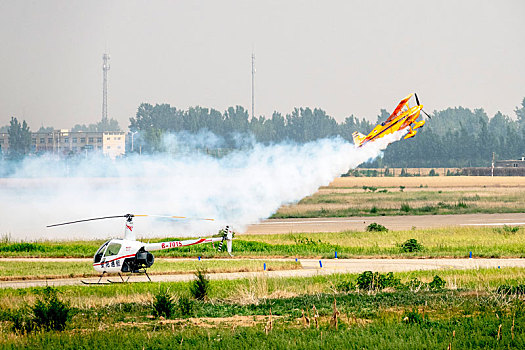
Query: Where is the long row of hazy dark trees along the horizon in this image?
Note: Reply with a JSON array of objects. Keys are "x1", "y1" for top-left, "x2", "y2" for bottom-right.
[{"x1": 129, "y1": 98, "x2": 525, "y2": 167}]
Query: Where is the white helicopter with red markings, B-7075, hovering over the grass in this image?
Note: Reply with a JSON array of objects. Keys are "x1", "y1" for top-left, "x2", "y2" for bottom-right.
[{"x1": 46, "y1": 214, "x2": 233, "y2": 284}]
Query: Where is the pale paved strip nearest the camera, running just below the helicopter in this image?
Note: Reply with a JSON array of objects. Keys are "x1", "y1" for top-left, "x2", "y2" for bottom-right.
[{"x1": 0, "y1": 259, "x2": 525, "y2": 288}]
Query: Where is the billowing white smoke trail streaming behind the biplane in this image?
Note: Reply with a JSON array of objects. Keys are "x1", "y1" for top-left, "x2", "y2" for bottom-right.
[{"x1": 0, "y1": 133, "x2": 403, "y2": 240}]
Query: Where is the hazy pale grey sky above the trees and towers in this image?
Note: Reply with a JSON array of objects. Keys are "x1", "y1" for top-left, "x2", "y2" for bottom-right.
[{"x1": 0, "y1": 0, "x2": 525, "y2": 129}]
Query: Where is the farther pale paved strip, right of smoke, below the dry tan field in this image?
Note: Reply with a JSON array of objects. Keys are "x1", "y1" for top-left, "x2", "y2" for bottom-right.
[{"x1": 246, "y1": 213, "x2": 525, "y2": 234}]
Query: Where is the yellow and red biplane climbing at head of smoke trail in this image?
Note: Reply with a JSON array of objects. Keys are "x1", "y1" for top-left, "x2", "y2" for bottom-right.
[{"x1": 352, "y1": 93, "x2": 430, "y2": 147}]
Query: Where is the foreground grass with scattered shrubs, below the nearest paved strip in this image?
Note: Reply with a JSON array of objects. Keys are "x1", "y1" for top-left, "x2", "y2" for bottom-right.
[{"x1": 0, "y1": 268, "x2": 525, "y2": 349}]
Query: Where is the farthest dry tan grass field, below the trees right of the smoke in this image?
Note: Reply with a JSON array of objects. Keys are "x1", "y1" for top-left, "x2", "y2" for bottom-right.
[{"x1": 273, "y1": 176, "x2": 525, "y2": 218}]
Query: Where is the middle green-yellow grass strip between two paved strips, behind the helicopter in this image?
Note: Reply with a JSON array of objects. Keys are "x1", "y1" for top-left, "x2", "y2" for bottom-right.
[{"x1": 0, "y1": 226, "x2": 525, "y2": 258}]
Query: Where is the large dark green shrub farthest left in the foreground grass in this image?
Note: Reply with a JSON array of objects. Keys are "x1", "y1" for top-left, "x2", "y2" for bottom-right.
[{"x1": 31, "y1": 287, "x2": 71, "y2": 331}]
